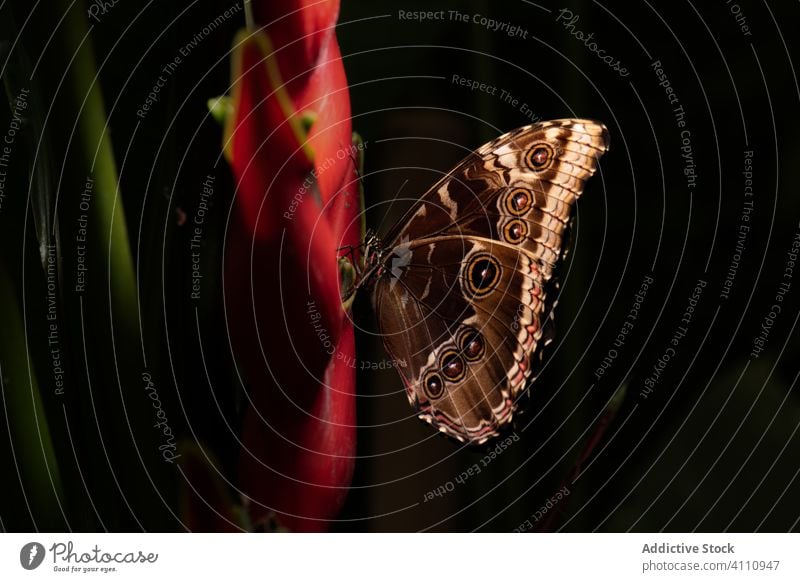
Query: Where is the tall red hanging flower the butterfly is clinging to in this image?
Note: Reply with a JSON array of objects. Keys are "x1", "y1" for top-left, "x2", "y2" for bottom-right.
[{"x1": 224, "y1": 0, "x2": 361, "y2": 531}]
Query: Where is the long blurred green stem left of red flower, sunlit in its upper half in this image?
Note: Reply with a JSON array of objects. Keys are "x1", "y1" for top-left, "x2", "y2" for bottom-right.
[{"x1": 53, "y1": 0, "x2": 174, "y2": 529}]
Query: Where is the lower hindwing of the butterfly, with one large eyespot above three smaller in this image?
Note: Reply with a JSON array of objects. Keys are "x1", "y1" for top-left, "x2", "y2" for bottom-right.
[{"x1": 375, "y1": 237, "x2": 543, "y2": 442}]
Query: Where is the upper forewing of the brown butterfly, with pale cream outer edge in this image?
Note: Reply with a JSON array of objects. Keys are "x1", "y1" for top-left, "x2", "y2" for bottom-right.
[{"x1": 386, "y1": 119, "x2": 608, "y2": 274}]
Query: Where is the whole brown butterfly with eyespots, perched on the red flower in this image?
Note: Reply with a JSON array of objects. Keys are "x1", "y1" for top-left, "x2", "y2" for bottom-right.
[{"x1": 344, "y1": 119, "x2": 609, "y2": 445}]
